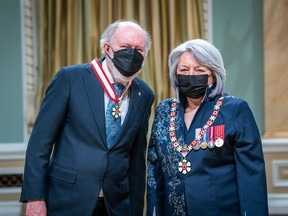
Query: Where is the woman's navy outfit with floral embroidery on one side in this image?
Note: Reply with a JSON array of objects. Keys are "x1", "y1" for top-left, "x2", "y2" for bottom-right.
[{"x1": 147, "y1": 95, "x2": 268, "y2": 216}]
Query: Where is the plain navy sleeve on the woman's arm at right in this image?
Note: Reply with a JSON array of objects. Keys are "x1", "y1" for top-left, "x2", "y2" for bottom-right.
[{"x1": 233, "y1": 100, "x2": 268, "y2": 216}]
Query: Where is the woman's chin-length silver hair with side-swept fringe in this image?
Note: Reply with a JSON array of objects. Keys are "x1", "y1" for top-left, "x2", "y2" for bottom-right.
[{"x1": 168, "y1": 39, "x2": 226, "y2": 97}]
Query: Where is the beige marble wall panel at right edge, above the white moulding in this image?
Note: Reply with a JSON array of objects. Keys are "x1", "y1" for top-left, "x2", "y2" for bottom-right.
[{"x1": 264, "y1": 0, "x2": 288, "y2": 138}]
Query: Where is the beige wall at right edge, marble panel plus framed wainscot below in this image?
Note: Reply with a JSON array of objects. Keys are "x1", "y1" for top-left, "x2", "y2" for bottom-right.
[{"x1": 263, "y1": 0, "x2": 288, "y2": 209}]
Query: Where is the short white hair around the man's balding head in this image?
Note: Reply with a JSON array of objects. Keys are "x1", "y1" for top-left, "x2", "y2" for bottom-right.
[{"x1": 100, "y1": 20, "x2": 151, "y2": 55}]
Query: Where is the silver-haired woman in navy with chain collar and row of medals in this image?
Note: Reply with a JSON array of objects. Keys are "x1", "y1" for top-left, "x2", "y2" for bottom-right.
[{"x1": 147, "y1": 39, "x2": 268, "y2": 216}]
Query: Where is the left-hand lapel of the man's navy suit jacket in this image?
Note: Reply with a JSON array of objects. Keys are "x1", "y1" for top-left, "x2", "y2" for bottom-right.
[{"x1": 84, "y1": 65, "x2": 106, "y2": 144}]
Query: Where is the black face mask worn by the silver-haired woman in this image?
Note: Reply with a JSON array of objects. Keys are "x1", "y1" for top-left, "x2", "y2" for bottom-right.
[{"x1": 177, "y1": 74, "x2": 208, "y2": 99}]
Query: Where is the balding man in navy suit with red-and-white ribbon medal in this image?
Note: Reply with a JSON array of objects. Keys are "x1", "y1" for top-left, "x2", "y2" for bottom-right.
[{"x1": 20, "y1": 21, "x2": 154, "y2": 216}]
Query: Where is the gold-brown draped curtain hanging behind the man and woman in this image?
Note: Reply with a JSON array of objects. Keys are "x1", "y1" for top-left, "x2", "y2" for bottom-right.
[{"x1": 36, "y1": 0, "x2": 205, "y2": 116}]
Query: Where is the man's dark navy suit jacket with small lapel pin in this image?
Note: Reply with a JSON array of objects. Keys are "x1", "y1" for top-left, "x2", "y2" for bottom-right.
[{"x1": 20, "y1": 59, "x2": 154, "y2": 216}]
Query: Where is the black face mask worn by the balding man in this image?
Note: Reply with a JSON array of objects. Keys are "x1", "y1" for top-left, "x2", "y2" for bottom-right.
[{"x1": 106, "y1": 48, "x2": 144, "y2": 77}]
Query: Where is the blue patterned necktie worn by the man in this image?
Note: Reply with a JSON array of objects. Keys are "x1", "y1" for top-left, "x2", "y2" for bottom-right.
[{"x1": 105, "y1": 83, "x2": 124, "y2": 148}]
